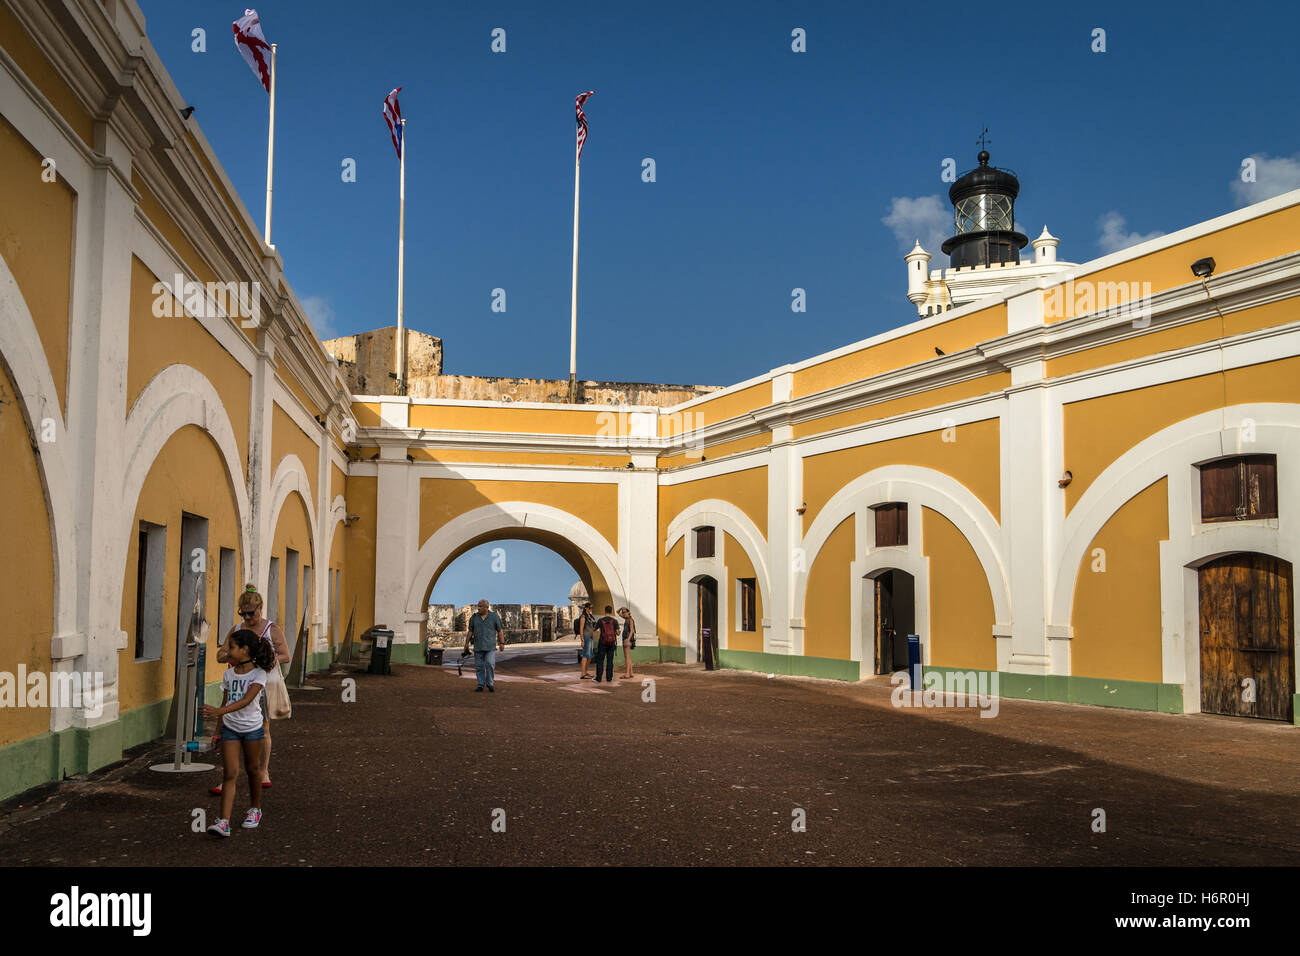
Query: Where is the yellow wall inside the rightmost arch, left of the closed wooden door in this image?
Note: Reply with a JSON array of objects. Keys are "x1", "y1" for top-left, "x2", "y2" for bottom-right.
[{"x1": 1070, "y1": 479, "x2": 1169, "y2": 683}]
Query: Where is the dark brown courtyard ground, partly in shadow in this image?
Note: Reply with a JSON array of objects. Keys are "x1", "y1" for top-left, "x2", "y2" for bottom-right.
[{"x1": 0, "y1": 644, "x2": 1300, "y2": 866}]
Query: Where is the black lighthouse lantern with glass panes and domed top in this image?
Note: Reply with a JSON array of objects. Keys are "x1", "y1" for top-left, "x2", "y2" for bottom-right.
[{"x1": 943, "y1": 150, "x2": 1030, "y2": 269}]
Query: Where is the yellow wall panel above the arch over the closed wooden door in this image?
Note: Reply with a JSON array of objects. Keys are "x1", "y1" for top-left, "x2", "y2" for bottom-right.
[{"x1": 1063, "y1": 356, "x2": 1300, "y2": 514}]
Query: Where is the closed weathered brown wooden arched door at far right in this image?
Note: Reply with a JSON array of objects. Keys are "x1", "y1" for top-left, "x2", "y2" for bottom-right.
[{"x1": 1197, "y1": 553, "x2": 1296, "y2": 721}]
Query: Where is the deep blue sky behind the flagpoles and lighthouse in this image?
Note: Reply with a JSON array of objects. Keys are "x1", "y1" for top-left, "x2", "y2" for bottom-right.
[{"x1": 140, "y1": 0, "x2": 1300, "y2": 593}]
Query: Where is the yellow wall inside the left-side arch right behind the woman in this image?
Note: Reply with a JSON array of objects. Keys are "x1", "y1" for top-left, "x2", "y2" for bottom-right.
[{"x1": 117, "y1": 425, "x2": 250, "y2": 713}]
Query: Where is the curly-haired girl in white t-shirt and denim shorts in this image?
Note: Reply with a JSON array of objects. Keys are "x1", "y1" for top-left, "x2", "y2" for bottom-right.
[{"x1": 203, "y1": 628, "x2": 276, "y2": 836}]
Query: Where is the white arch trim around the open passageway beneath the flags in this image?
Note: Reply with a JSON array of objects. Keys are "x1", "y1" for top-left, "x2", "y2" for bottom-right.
[{"x1": 398, "y1": 501, "x2": 628, "y2": 643}]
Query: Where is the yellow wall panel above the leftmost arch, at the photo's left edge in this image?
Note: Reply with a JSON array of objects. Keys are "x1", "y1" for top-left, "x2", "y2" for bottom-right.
[{"x1": 0, "y1": 113, "x2": 77, "y2": 412}]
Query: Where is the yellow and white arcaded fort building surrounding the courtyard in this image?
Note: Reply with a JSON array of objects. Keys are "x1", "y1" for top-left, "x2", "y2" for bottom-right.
[{"x1": 0, "y1": 0, "x2": 1300, "y2": 797}]
